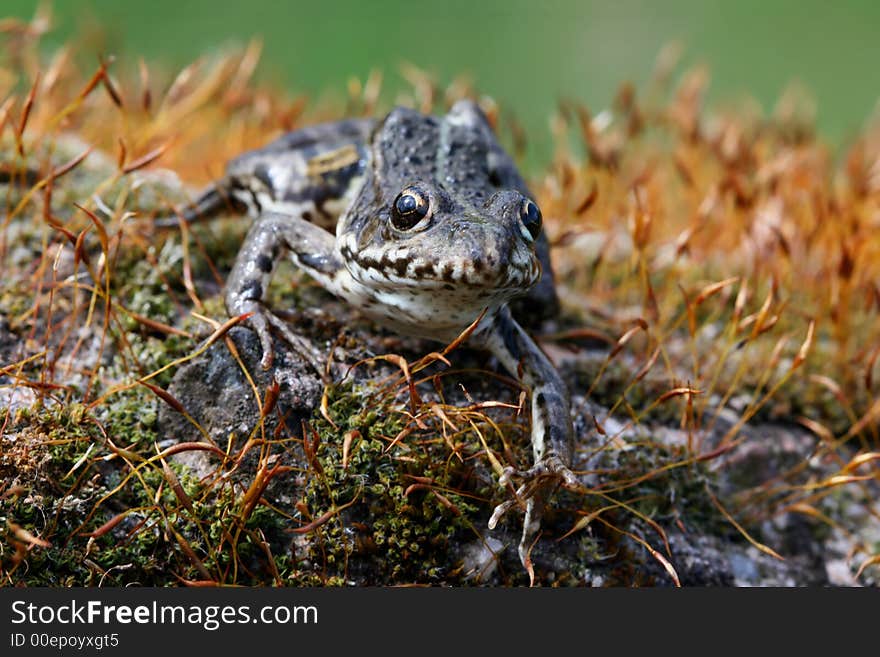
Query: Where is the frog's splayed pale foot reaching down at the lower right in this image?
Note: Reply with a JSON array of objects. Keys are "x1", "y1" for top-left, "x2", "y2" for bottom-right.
[{"x1": 489, "y1": 455, "x2": 579, "y2": 569}]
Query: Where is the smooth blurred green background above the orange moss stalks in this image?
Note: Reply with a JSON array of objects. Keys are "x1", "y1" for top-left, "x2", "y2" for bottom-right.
[{"x1": 2, "y1": 0, "x2": 880, "y2": 158}]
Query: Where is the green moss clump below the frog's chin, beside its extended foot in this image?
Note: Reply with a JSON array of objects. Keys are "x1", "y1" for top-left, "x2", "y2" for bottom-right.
[{"x1": 292, "y1": 386, "x2": 476, "y2": 583}]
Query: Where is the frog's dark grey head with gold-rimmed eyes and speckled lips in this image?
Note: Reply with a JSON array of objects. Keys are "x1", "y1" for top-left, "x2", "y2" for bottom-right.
[{"x1": 339, "y1": 106, "x2": 541, "y2": 303}]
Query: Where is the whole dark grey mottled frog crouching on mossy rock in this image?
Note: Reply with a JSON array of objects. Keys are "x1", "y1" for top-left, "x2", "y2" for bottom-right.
[{"x1": 155, "y1": 100, "x2": 577, "y2": 567}]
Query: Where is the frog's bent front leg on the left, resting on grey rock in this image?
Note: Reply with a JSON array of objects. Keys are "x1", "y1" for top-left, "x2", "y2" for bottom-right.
[{"x1": 226, "y1": 212, "x2": 342, "y2": 376}]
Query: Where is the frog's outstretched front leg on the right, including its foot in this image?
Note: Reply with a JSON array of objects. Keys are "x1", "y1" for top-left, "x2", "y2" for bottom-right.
[{"x1": 475, "y1": 308, "x2": 578, "y2": 564}]
